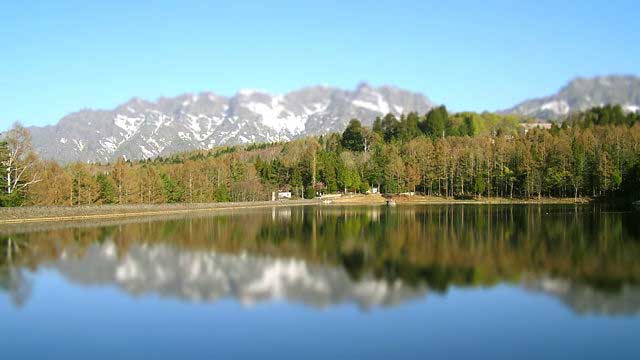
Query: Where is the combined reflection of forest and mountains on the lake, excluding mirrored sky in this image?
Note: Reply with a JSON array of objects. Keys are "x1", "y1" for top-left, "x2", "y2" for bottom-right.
[{"x1": 0, "y1": 205, "x2": 640, "y2": 314}]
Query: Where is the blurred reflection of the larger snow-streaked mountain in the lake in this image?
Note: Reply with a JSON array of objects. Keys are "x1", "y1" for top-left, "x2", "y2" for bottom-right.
[{"x1": 50, "y1": 241, "x2": 427, "y2": 309}]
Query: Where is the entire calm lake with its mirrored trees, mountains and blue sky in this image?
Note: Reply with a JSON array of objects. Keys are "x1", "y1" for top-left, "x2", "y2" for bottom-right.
[{"x1": 0, "y1": 205, "x2": 640, "y2": 359}]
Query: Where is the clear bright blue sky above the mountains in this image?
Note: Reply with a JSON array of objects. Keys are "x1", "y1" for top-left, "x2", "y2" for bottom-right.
[{"x1": 0, "y1": 0, "x2": 640, "y2": 129}]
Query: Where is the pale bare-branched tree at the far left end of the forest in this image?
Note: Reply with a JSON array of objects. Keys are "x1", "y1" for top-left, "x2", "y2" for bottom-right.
[{"x1": 2, "y1": 124, "x2": 42, "y2": 195}]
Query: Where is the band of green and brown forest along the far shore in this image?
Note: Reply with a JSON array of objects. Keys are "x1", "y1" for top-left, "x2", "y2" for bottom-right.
[{"x1": 0, "y1": 105, "x2": 640, "y2": 206}]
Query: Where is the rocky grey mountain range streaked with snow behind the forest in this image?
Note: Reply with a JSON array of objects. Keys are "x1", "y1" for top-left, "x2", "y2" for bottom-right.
[{"x1": 12, "y1": 76, "x2": 640, "y2": 163}]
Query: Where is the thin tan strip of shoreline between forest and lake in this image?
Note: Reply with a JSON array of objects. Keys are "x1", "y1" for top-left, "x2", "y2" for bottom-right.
[{"x1": 0, "y1": 195, "x2": 592, "y2": 225}]
